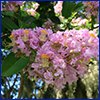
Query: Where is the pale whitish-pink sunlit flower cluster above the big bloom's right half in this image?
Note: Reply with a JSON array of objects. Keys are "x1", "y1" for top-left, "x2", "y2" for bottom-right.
[{"x1": 72, "y1": 17, "x2": 87, "y2": 26}]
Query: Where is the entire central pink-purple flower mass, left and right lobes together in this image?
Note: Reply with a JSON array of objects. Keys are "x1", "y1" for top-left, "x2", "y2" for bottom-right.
[{"x1": 10, "y1": 27, "x2": 99, "y2": 91}]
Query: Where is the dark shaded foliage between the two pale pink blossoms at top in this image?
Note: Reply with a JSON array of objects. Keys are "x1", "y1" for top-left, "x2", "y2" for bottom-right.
[{"x1": 36, "y1": 1, "x2": 60, "y2": 24}]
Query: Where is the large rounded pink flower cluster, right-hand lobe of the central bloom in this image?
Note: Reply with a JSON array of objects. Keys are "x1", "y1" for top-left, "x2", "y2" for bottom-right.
[{"x1": 22, "y1": 29, "x2": 99, "y2": 90}]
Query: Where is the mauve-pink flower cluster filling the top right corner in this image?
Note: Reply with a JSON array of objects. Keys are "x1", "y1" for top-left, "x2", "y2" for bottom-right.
[{"x1": 83, "y1": 1, "x2": 99, "y2": 22}]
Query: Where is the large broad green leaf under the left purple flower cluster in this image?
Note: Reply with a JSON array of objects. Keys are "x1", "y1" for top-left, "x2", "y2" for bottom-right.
[{"x1": 1, "y1": 53, "x2": 30, "y2": 76}]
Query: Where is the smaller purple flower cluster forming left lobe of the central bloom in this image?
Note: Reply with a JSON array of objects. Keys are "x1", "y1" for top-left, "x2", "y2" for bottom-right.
[{"x1": 9, "y1": 27, "x2": 53, "y2": 56}]
